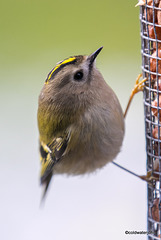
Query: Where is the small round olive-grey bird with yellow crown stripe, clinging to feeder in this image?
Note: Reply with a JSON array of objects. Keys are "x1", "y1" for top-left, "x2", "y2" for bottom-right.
[{"x1": 38, "y1": 47, "x2": 146, "y2": 198}]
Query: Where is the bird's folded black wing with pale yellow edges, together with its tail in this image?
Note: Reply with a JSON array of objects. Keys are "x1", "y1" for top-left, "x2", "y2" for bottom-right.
[{"x1": 40, "y1": 134, "x2": 69, "y2": 198}]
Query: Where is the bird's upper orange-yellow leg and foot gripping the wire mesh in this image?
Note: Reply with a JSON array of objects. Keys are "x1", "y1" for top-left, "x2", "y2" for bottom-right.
[{"x1": 124, "y1": 73, "x2": 147, "y2": 118}]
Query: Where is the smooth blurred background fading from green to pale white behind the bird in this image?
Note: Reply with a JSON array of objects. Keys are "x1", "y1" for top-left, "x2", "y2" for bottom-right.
[{"x1": 0, "y1": 0, "x2": 146, "y2": 240}]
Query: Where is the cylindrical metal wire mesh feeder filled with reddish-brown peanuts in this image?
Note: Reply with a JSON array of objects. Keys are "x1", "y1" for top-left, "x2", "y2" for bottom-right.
[{"x1": 140, "y1": 0, "x2": 161, "y2": 240}]
